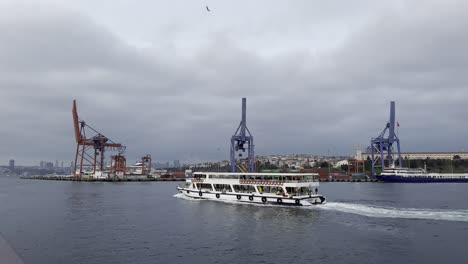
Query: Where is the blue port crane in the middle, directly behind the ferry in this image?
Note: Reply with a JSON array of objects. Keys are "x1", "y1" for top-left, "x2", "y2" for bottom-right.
[{"x1": 231, "y1": 98, "x2": 255, "y2": 172}]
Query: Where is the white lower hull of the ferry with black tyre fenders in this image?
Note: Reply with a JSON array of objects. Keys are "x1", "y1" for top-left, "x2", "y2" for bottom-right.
[{"x1": 177, "y1": 187, "x2": 326, "y2": 206}]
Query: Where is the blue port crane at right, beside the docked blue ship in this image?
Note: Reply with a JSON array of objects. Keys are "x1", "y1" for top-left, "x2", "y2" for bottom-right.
[{"x1": 370, "y1": 101, "x2": 401, "y2": 176}]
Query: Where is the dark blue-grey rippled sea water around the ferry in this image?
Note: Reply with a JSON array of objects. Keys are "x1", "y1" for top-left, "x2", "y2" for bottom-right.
[{"x1": 0, "y1": 177, "x2": 468, "y2": 264}]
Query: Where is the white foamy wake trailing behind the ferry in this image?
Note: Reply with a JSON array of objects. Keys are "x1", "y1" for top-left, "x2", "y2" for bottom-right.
[{"x1": 317, "y1": 202, "x2": 468, "y2": 222}]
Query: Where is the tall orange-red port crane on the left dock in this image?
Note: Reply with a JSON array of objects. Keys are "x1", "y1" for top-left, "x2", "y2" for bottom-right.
[{"x1": 72, "y1": 100, "x2": 125, "y2": 179}]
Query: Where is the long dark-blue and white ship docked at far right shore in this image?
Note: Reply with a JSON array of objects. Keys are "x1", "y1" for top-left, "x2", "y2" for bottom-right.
[{"x1": 377, "y1": 168, "x2": 468, "y2": 182}]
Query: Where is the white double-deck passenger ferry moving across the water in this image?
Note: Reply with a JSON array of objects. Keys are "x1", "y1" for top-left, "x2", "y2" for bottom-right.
[{"x1": 177, "y1": 172, "x2": 325, "y2": 205}]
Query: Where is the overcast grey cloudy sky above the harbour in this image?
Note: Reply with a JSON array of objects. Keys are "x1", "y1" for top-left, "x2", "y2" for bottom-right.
[{"x1": 0, "y1": 0, "x2": 468, "y2": 164}]
